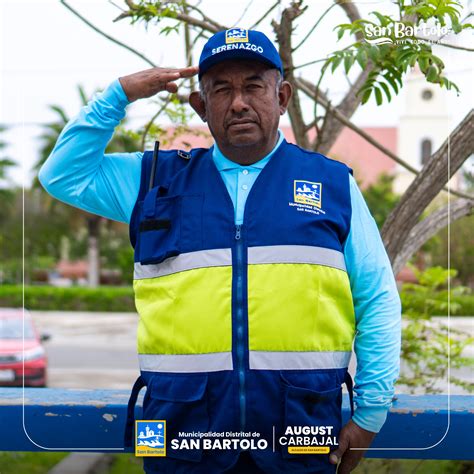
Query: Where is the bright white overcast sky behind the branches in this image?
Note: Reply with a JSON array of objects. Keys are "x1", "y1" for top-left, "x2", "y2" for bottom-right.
[{"x1": 0, "y1": 0, "x2": 474, "y2": 186}]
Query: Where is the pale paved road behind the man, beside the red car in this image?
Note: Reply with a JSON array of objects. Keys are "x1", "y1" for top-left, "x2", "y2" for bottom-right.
[{"x1": 32, "y1": 311, "x2": 474, "y2": 394}]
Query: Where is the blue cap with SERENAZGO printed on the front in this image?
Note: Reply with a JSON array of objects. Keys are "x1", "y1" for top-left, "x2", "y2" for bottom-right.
[{"x1": 199, "y1": 28, "x2": 283, "y2": 79}]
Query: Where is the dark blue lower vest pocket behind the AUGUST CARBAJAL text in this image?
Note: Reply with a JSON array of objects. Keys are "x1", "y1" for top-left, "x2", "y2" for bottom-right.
[{"x1": 280, "y1": 373, "x2": 342, "y2": 466}]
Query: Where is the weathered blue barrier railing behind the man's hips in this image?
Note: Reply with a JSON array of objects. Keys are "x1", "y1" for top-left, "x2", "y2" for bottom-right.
[{"x1": 0, "y1": 388, "x2": 474, "y2": 460}]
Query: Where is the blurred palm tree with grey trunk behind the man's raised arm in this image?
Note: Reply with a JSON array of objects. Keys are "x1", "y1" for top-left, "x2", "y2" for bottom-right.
[{"x1": 33, "y1": 86, "x2": 140, "y2": 286}]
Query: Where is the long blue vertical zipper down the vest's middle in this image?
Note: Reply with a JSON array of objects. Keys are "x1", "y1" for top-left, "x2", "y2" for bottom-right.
[{"x1": 235, "y1": 224, "x2": 246, "y2": 430}]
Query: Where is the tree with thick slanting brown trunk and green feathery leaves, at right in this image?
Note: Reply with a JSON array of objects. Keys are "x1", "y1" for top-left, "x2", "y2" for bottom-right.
[{"x1": 61, "y1": 0, "x2": 474, "y2": 273}]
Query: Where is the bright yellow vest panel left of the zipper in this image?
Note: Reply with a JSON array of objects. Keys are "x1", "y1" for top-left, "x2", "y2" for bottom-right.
[{"x1": 133, "y1": 266, "x2": 232, "y2": 354}]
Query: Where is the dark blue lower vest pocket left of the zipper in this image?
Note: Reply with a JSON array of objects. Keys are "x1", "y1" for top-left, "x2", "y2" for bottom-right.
[{"x1": 143, "y1": 374, "x2": 209, "y2": 462}]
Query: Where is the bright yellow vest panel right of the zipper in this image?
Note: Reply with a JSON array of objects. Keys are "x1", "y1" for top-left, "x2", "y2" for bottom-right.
[{"x1": 248, "y1": 263, "x2": 355, "y2": 351}]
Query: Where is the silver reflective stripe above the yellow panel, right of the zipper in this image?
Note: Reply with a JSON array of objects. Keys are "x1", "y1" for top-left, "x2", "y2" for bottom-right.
[{"x1": 248, "y1": 245, "x2": 346, "y2": 271}]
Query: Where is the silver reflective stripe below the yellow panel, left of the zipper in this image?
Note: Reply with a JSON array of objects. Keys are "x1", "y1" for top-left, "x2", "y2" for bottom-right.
[{"x1": 138, "y1": 352, "x2": 232, "y2": 373}]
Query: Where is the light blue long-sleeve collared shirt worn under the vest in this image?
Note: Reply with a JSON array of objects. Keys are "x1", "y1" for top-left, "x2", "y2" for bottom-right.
[{"x1": 39, "y1": 80, "x2": 401, "y2": 432}]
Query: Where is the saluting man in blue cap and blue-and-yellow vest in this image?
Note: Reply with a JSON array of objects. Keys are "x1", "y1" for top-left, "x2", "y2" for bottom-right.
[{"x1": 39, "y1": 28, "x2": 400, "y2": 474}]
